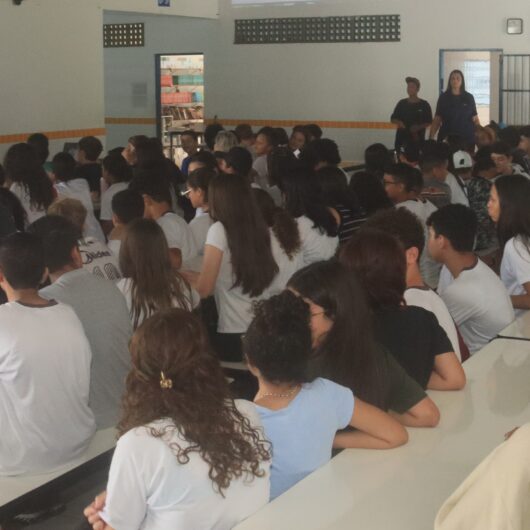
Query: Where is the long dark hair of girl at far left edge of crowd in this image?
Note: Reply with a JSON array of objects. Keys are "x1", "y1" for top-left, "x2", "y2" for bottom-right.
[{"x1": 4, "y1": 143, "x2": 53, "y2": 210}]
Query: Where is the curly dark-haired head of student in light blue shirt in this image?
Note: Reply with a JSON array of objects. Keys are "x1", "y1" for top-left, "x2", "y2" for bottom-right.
[{"x1": 243, "y1": 291, "x2": 311, "y2": 384}]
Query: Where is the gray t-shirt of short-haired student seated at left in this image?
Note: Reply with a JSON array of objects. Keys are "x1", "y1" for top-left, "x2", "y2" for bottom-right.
[{"x1": 40, "y1": 269, "x2": 132, "y2": 429}]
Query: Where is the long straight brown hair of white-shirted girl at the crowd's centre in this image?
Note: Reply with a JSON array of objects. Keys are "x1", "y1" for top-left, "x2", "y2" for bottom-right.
[{"x1": 208, "y1": 173, "x2": 279, "y2": 297}]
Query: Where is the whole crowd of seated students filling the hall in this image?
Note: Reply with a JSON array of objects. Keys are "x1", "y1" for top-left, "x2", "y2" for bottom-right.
[{"x1": 0, "y1": 117, "x2": 530, "y2": 529}]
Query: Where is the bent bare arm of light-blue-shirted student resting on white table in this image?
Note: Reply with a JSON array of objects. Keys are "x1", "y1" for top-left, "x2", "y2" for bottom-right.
[{"x1": 333, "y1": 399, "x2": 408, "y2": 449}]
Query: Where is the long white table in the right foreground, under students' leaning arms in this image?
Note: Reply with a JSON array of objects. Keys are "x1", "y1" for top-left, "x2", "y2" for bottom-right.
[{"x1": 236, "y1": 339, "x2": 530, "y2": 530}]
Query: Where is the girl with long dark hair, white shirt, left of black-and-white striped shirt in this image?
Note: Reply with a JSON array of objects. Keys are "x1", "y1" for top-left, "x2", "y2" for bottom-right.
[{"x1": 280, "y1": 166, "x2": 340, "y2": 265}]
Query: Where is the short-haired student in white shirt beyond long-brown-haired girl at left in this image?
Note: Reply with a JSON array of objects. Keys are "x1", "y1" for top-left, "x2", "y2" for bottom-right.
[{"x1": 129, "y1": 170, "x2": 197, "y2": 269}]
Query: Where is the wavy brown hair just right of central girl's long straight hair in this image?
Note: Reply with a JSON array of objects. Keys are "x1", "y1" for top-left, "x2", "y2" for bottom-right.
[{"x1": 252, "y1": 189, "x2": 302, "y2": 259}]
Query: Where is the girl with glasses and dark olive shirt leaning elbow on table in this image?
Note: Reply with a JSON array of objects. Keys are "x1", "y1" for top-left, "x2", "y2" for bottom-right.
[{"x1": 288, "y1": 260, "x2": 440, "y2": 427}]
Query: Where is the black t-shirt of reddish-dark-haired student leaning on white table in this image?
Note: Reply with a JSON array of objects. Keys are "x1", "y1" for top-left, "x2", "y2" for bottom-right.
[{"x1": 375, "y1": 306, "x2": 453, "y2": 388}]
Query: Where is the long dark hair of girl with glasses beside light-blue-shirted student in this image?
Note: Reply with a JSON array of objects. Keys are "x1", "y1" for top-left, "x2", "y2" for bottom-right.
[{"x1": 288, "y1": 260, "x2": 389, "y2": 409}]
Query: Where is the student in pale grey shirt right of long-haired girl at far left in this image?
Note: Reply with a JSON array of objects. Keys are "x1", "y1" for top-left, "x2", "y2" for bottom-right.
[{"x1": 52, "y1": 153, "x2": 105, "y2": 243}]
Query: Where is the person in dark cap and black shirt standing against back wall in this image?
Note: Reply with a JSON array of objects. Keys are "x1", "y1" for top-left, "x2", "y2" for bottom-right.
[{"x1": 390, "y1": 77, "x2": 432, "y2": 151}]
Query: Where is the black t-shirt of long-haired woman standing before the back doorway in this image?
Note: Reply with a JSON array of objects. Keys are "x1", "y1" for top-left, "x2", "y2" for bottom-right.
[{"x1": 436, "y1": 92, "x2": 477, "y2": 145}]
